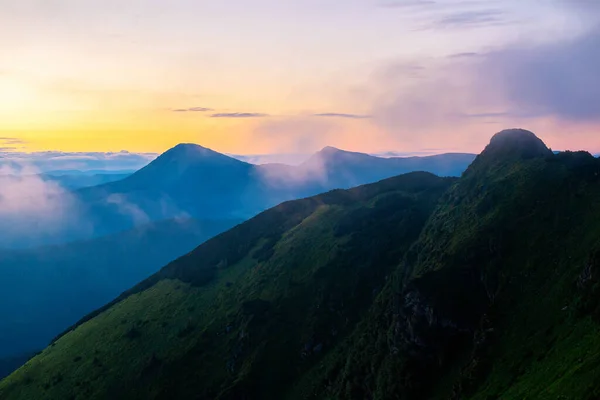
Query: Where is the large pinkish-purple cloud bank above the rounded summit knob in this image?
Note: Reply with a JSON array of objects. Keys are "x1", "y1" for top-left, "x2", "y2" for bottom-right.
[{"x1": 363, "y1": 1, "x2": 600, "y2": 148}]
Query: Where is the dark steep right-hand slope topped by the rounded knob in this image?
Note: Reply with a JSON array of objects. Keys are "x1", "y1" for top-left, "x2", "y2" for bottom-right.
[{"x1": 290, "y1": 130, "x2": 600, "y2": 399}]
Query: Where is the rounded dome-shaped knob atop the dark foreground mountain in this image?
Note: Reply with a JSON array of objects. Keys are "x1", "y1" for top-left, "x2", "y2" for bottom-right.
[{"x1": 481, "y1": 129, "x2": 552, "y2": 158}]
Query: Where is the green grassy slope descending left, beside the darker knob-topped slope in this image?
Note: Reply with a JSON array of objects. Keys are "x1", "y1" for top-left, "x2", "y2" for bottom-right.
[{"x1": 0, "y1": 173, "x2": 455, "y2": 399}]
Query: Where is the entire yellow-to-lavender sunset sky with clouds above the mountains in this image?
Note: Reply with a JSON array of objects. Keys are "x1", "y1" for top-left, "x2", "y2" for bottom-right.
[{"x1": 0, "y1": 0, "x2": 600, "y2": 155}]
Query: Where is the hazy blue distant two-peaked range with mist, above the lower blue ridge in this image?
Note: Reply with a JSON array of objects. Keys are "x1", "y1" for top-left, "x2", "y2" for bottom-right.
[{"x1": 0, "y1": 143, "x2": 474, "y2": 249}]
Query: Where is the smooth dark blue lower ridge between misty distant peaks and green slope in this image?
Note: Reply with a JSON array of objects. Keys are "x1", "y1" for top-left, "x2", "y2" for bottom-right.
[{"x1": 0, "y1": 219, "x2": 241, "y2": 358}]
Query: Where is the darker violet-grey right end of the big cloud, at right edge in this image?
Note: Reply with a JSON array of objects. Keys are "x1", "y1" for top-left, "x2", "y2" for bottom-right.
[{"x1": 474, "y1": 24, "x2": 600, "y2": 122}]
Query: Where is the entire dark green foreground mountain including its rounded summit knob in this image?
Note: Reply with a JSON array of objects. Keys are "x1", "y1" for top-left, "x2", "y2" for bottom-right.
[{"x1": 0, "y1": 130, "x2": 600, "y2": 400}]
